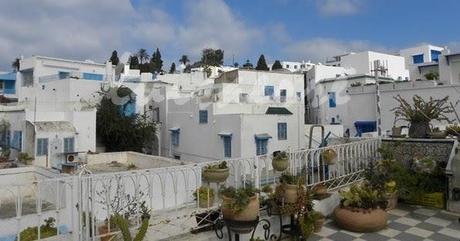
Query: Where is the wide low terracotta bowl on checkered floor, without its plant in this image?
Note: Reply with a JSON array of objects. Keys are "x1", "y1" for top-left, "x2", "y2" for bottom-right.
[{"x1": 334, "y1": 207, "x2": 388, "y2": 233}]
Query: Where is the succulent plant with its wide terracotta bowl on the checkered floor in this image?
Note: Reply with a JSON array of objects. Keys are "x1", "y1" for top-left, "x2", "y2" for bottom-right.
[{"x1": 334, "y1": 183, "x2": 388, "y2": 233}]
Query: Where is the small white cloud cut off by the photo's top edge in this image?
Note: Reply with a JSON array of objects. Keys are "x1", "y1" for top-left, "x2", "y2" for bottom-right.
[{"x1": 316, "y1": 0, "x2": 363, "y2": 16}]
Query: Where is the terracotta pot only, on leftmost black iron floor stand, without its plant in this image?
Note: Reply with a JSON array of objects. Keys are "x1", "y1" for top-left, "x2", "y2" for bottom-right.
[{"x1": 221, "y1": 195, "x2": 260, "y2": 221}]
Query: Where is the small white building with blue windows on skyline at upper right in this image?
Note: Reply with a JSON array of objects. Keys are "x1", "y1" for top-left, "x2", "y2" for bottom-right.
[{"x1": 399, "y1": 44, "x2": 444, "y2": 81}]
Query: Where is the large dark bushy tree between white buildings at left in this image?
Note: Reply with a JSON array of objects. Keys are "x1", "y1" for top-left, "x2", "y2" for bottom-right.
[{"x1": 96, "y1": 86, "x2": 156, "y2": 152}]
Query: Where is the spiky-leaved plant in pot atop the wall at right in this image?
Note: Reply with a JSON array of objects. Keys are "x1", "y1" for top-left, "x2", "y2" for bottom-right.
[{"x1": 392, "y1": 95, "x2": 453, "y2": 138}]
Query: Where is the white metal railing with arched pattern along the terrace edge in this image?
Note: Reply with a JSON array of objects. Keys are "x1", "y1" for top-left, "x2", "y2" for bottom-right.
[{"x1": 0, "y1": 139, "x2": 380, "y2": 241}]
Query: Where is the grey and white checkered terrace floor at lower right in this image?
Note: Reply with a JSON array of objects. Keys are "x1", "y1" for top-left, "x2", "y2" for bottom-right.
[{"x1": 308, "y1": 204, "x2": 460, "y2": 241}]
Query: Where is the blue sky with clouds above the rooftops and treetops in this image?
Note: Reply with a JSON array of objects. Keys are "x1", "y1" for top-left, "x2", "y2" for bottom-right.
[{"x1": 0, "y1": 0, "x2": 460, "y2": 70}]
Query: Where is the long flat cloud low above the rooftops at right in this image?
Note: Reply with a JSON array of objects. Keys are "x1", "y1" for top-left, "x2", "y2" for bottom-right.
[{"x1": 282, "y1": 38, "x2": 392, "y2": 62}]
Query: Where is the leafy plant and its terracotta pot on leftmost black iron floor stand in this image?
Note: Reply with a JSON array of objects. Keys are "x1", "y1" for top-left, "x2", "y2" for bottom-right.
[{"x1": 220, "y1": 187, "x2": 260, "y2": 221}]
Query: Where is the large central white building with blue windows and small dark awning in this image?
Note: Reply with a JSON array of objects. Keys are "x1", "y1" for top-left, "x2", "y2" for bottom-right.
[{"x1": 154, "y1": 70, "x2": 305, "y2": 161}]
